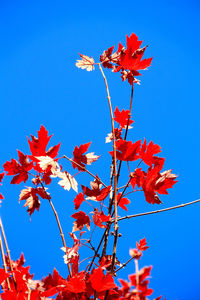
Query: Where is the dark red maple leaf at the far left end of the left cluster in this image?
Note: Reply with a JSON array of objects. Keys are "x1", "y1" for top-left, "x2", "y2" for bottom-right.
[{"x1": 3, "y1": 150, "x2": 33, "y2": 184}]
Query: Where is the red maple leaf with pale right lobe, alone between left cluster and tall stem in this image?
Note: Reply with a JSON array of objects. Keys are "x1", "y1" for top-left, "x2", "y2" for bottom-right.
[{"x1": 72, "y1": 142, "x2": 100, "y2": 171}]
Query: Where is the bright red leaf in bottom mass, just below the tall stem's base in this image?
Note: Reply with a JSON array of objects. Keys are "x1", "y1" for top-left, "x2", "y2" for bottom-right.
[{"x1": 90, "y1": 267, "x2": 117, "y2": 293}]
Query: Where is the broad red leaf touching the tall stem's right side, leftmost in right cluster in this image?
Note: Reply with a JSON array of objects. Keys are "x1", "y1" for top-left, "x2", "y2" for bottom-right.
[{"x1": 109, "y1": 140, "x2": 141, "y2": 161}]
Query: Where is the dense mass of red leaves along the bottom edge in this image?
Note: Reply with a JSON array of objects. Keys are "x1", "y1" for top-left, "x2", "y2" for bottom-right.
[{"x1": 0, "y1": 254, "x2": 161, "y2": 300}]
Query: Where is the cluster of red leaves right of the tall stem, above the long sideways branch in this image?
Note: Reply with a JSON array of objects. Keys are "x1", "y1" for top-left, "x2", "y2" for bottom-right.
[{"x1": 110, "y1": 139, "x2": 177, "y2": 204}]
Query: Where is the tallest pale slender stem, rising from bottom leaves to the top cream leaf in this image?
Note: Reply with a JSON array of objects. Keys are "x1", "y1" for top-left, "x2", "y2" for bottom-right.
[{"x1": 99, "y1": 64, "x2": 118, "y2": 272}]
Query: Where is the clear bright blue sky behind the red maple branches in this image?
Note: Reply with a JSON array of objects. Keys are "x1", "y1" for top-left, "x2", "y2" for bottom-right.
[{"x1": 0, "y1": 0, "x2": 200, "y2": 300}]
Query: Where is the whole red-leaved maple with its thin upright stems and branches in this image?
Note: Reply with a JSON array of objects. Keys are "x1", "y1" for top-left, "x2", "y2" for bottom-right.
[{"x1": 0, "y1": 33, "x2": 199, "y2": 300}]
